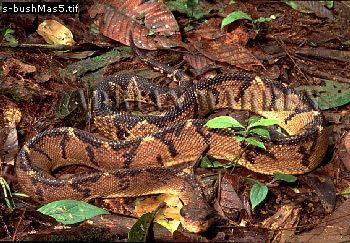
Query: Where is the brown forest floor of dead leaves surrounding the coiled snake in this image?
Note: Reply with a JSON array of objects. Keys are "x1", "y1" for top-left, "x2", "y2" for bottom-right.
[{"x1": 0, "y1": 0, "x2": 350, "y2": 242}]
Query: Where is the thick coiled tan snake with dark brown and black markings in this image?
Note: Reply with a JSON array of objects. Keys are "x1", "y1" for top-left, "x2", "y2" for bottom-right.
[{"x1": 16, "y1": 41, "x2": 327, "y2": 232}]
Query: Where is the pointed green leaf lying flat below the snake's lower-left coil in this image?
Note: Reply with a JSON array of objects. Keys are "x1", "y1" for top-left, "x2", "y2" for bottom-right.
[{"x1": 38, "y1": 200, "x2": 109, "y2": 224}]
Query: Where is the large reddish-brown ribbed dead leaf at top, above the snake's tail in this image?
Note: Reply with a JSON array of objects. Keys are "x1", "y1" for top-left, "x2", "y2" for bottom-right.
[{"x1": 89, "y1": 0, "x2": 181, "y2": 50}]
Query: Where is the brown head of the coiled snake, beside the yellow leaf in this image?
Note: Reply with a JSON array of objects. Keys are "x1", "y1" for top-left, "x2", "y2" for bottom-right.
[{"x1": 180, "y1": 204, "x2": 215, "y2": 233}]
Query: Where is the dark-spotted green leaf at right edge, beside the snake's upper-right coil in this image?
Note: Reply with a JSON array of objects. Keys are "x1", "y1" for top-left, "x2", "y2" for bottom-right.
[{"x1": 297, "y1": 80, "x2": 350, "y2": 110}]
